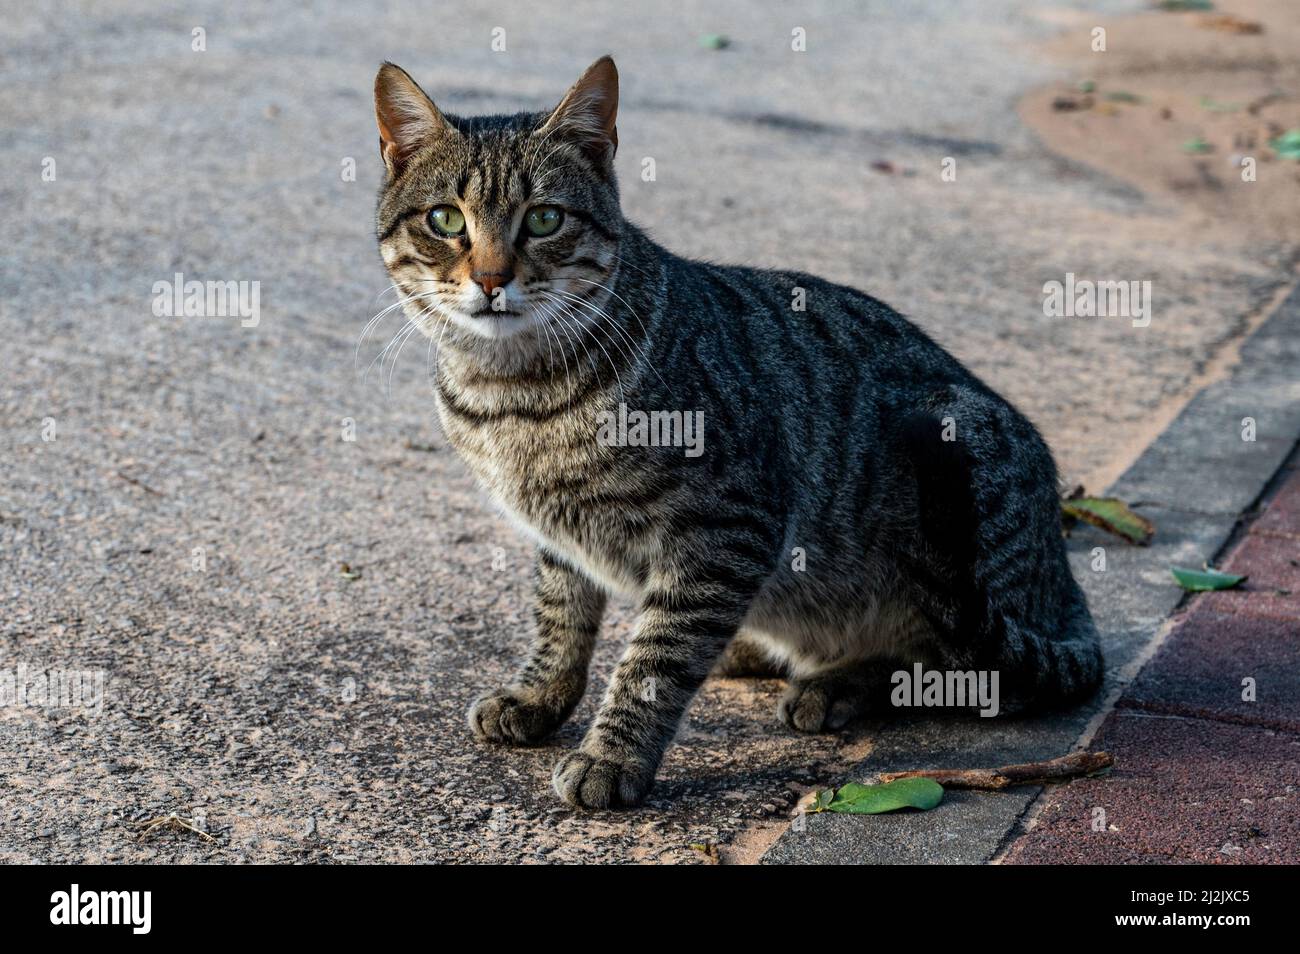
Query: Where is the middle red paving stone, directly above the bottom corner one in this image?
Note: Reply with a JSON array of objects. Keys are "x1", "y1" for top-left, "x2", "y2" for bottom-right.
[{"x1": 1119, "y1": 607, "x2": 1300, "y2": 734}]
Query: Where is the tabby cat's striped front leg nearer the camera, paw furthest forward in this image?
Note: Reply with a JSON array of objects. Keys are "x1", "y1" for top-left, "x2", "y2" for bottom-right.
[{"x1": 553, "y1": 574, "x2": 754, "y2": 808}]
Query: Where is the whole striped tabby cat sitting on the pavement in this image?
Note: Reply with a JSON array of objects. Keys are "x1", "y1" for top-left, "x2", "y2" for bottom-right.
[{"x1": 374, "y1": 57, "x2": 1102, "y2": 808}]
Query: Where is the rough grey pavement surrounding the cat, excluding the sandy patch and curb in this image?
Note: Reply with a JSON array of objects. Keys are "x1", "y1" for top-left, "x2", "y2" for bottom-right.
[{"x1": 0, "y1": 0, "x2": 1295, "y2": 862}]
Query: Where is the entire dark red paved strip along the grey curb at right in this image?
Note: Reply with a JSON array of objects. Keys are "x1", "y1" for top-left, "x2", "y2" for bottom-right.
[{"x1": 1005, "y1": 469, "x2": 1300, "y2": 864}]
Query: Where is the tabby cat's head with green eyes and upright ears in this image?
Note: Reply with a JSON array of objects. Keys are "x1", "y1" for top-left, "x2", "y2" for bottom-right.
[{"x1": 374, "y1": 56, "x2": 623, "y2": 361}]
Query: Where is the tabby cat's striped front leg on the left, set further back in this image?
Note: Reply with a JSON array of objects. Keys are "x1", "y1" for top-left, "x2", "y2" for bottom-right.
[{"x1": 469, "y1": 550, "x2": 606, "y2": 745}]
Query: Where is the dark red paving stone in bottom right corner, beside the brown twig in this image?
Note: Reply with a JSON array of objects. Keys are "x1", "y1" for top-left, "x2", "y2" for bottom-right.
[{"x1": 1004, "y1": 710, "x2": 1300, "y2": 864}]
